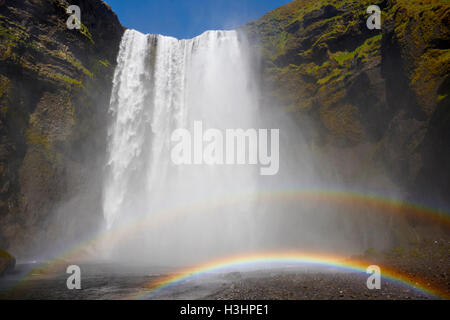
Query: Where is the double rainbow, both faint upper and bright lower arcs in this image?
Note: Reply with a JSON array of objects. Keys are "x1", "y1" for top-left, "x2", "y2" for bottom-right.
[{"x1": 4, "y1": 189, "x2": 450, "y2": 299}]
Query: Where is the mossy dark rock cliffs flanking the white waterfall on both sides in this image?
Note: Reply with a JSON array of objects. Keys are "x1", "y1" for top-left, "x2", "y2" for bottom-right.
[{"x1": 0, "y1": 0, "x2": 450, "y2": 256}]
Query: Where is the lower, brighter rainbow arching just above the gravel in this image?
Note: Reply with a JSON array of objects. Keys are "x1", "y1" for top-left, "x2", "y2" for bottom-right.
[{"x1": 126, "y1": 251, "x2": 450, "y2": 300}]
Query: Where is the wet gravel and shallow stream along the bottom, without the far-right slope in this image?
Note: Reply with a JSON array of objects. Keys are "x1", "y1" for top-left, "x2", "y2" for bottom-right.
[{"x1": 0, "y1": 270, "x2": 435, "y2": 300}]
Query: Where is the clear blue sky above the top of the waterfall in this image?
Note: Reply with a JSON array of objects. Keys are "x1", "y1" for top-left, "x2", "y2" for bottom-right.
[{"x1": 105, "y1": 0, "x2": 291, "y2": 39}]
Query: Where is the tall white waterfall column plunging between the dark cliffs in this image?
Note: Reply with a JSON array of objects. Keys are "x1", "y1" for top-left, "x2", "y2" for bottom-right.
[{"x1": 103, "y1": 30, "x2": 258, "y2": 264}]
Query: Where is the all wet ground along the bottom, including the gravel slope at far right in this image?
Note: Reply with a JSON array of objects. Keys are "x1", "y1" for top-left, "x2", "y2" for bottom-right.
[{"x1": 0, "y1": 241, "x2": 450, "y2": 300}]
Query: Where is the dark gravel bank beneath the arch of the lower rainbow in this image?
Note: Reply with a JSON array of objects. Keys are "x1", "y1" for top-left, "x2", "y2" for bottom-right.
[{"x1": 209, "y1": 272, "x2": 433, "y2": 300}]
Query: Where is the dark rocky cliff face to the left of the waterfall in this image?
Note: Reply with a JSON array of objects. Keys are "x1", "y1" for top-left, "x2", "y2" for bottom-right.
[{"x1": 0, "y1": 0, "x2": 124, "y2": 253}]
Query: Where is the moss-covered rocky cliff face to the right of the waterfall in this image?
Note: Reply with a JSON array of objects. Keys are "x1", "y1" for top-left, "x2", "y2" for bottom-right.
[{"x1": 243, "y1": 0, "x2": 450, "y2": 210}]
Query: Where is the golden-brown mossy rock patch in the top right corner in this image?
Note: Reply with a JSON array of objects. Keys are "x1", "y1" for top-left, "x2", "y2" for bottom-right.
[{"x1": 387, "y1": 0, "x2": 450, "y2": 115}]
